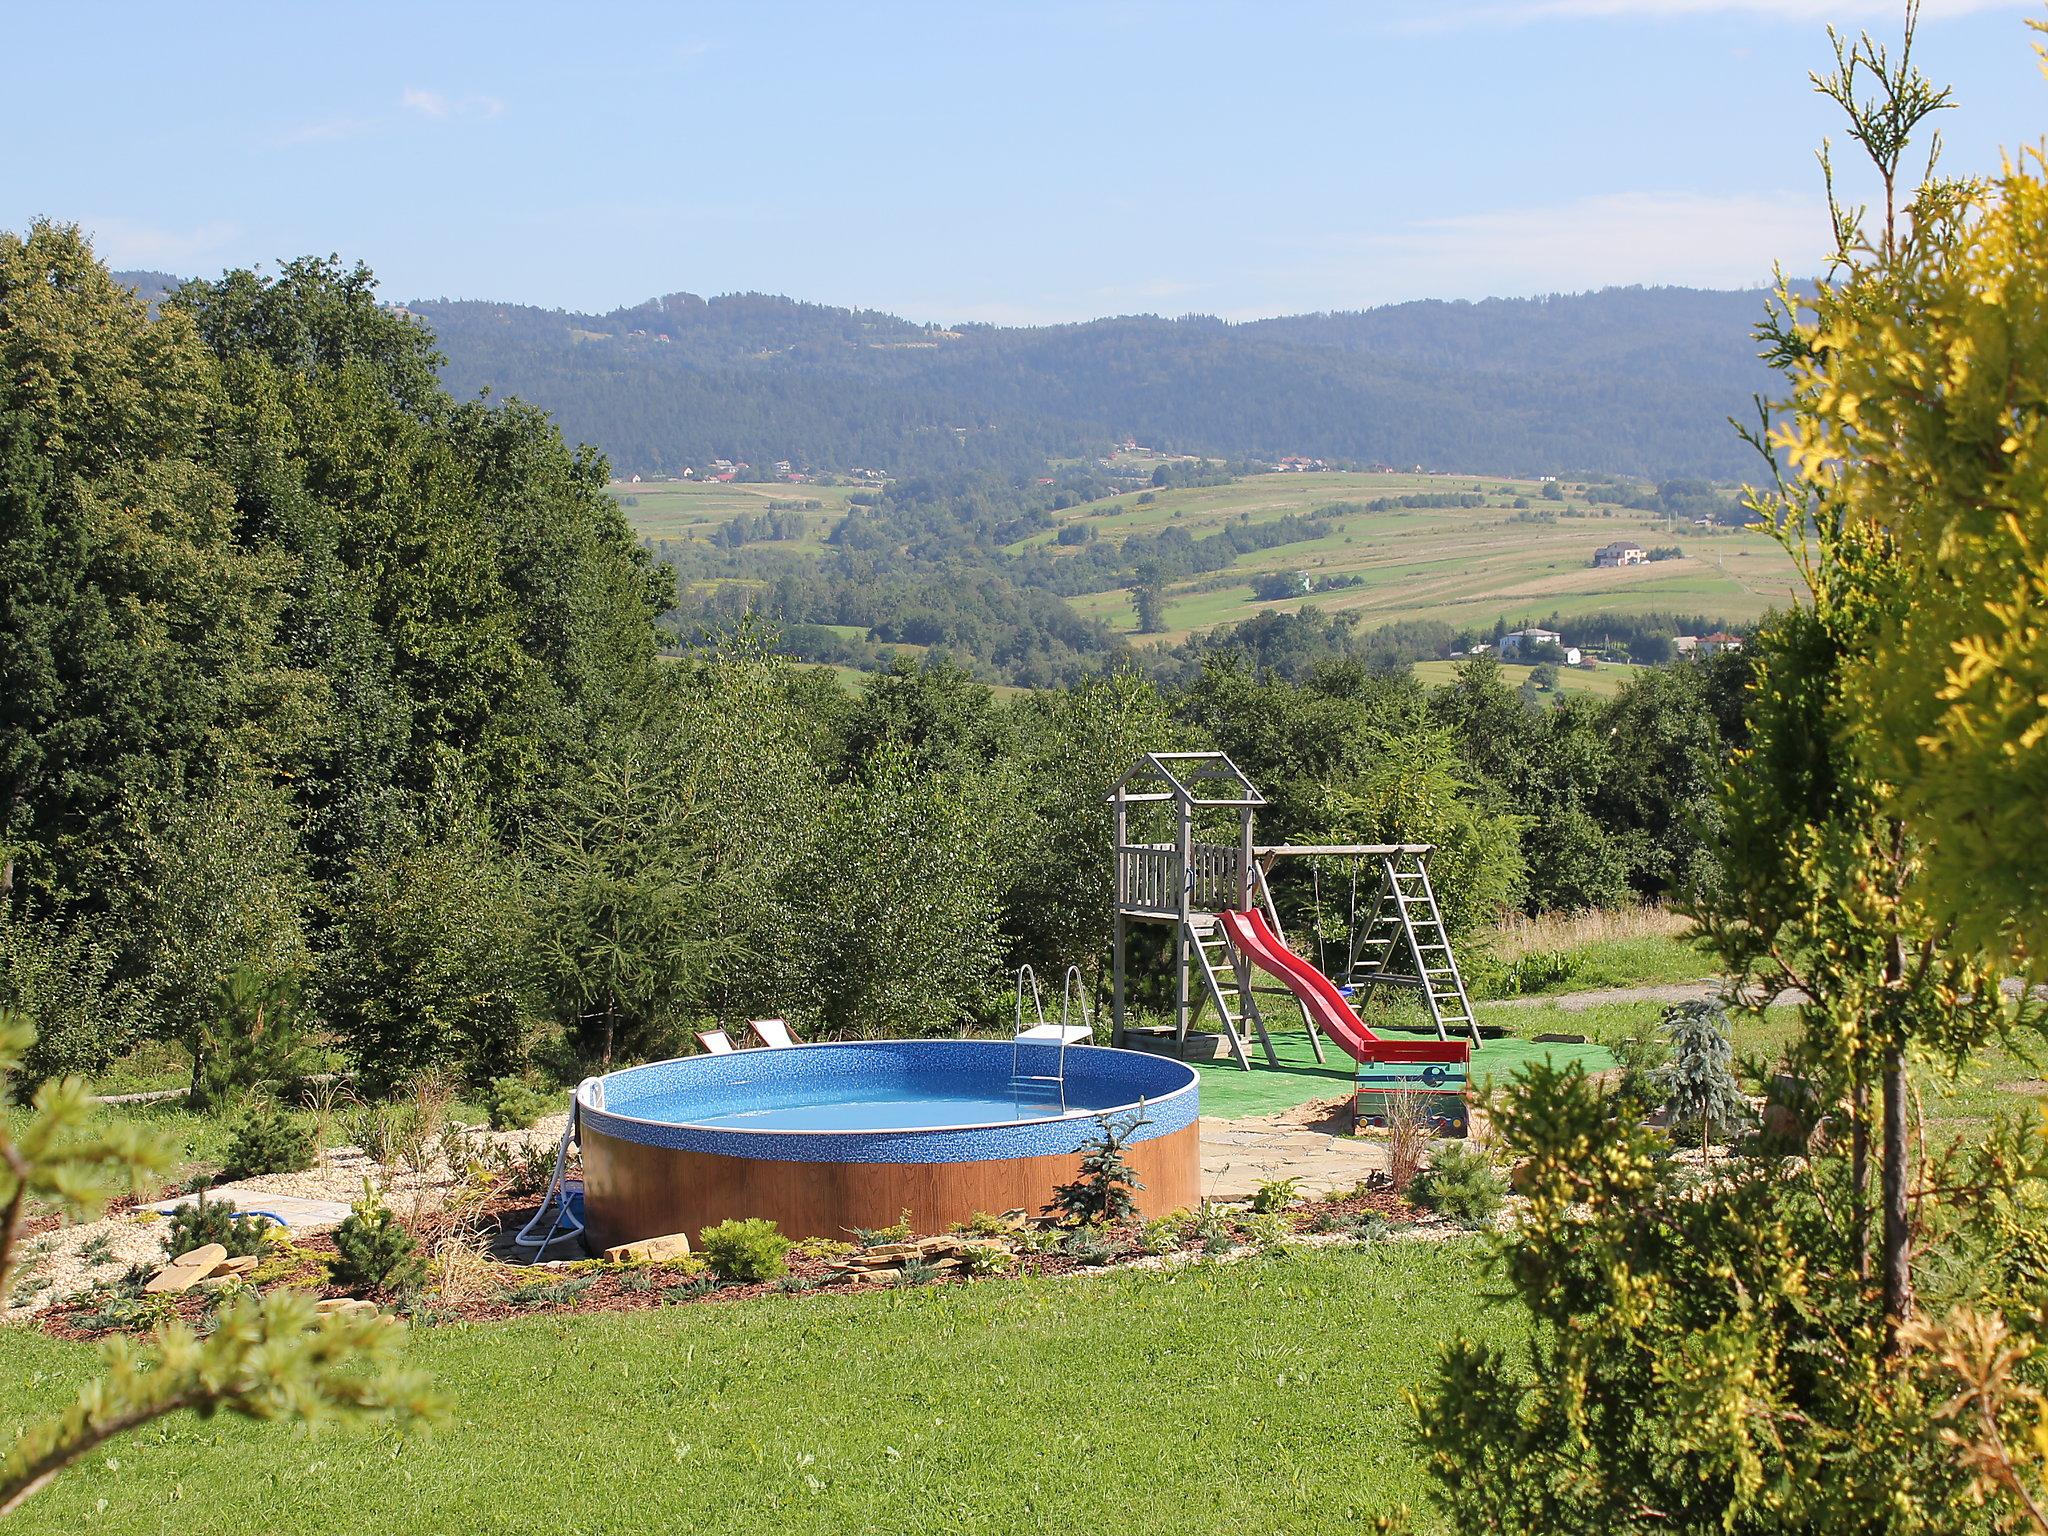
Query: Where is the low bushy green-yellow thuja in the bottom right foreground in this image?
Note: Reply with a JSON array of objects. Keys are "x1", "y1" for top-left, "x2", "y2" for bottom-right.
[{"x1": 1415, "y1": 1065, "x2": 2015, "y2": 1536}]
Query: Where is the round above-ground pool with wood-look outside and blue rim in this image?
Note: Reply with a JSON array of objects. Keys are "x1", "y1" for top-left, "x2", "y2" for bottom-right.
[{"x1": 575, "y1": 1040, "x2": 1200, "y2": 1247}]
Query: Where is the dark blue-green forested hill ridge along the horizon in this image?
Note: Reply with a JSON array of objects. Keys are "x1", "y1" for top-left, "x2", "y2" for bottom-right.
[{"x1": 395, "y1": 289, "x2": 1765, "y2": 477}]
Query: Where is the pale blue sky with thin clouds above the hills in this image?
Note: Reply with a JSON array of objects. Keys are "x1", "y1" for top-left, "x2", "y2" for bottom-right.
[{"x1": 0, "y1": 0, "x2": 2048, "y2": 324}]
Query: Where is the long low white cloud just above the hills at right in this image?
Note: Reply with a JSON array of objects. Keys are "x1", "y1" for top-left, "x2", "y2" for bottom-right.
[{"x1": 1266, "y1": 193, "x2": 1827, "y2": 313}]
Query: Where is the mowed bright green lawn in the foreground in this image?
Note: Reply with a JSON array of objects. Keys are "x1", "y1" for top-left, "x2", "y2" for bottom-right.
[{"x1": 0, "y1": 1241, "x2": 1518, "y2": 1536}]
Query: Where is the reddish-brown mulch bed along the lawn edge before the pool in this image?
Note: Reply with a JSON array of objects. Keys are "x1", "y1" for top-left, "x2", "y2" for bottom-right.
[{"x1": 37, "y1": 1188, "x2": 1421, "y2": 1339}]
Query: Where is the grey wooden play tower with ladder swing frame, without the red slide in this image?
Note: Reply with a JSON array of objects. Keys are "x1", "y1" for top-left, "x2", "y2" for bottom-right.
[{"x1": 1110, "y1": 752, "x2": 1479, "y2": 1071}]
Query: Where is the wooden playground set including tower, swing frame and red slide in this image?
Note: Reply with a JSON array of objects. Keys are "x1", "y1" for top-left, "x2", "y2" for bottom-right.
[{"x1": 1110, "y1": 752, "x2": 1479, "y2": 1092}]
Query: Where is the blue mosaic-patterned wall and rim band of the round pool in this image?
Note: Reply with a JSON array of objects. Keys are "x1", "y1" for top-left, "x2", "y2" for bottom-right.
[{"x1": 580, "y1": 1040, "x2": 1200, "y2": 1163}]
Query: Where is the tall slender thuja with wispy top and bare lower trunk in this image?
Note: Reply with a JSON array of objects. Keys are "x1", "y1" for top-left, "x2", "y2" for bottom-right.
[{"x1": 1700, "y1": 4, "x2": 2007, "y2": 1331}]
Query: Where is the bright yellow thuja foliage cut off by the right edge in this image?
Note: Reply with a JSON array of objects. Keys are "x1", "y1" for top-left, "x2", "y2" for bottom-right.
[{"x1": 1780, "y1": 23, "x2": 2048, "y2": 971}]
